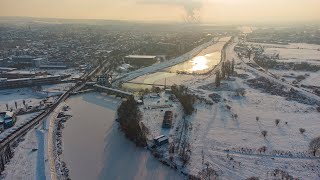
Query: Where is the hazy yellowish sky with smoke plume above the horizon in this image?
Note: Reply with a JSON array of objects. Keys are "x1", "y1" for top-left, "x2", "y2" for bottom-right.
[{"x1": 0, "y1": 0, "x2": 320, "y2": 23}]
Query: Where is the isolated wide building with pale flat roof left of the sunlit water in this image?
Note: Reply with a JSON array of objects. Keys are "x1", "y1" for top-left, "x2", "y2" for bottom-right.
[{"x1": 124, "y1": 55, "x2": 157, "y2": 67}]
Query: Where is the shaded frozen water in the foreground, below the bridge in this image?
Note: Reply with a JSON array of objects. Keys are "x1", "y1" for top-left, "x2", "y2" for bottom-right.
[{"x1": 63, "y1": 93, "x2": 182, "y2": 180}]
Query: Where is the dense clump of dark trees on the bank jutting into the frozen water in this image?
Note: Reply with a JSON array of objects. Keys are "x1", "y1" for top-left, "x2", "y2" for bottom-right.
[{"x1": 117, "y1": 97, "x2": 147, "y2": 147}]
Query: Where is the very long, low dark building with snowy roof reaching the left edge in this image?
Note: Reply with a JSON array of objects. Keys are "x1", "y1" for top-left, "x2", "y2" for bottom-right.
[{"x1": 0, "y1": 75, "x2": 68, "y2": 89}]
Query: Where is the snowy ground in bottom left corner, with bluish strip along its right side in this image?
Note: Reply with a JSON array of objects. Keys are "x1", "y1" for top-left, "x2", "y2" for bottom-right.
[{"x1": 1, "y1": 116, "x2": 48, "y2": 180}]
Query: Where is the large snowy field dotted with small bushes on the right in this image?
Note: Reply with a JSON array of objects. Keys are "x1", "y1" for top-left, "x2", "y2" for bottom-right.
[{"x1": 185, "y1": 74, "x2": 320, "y2": 179}]
